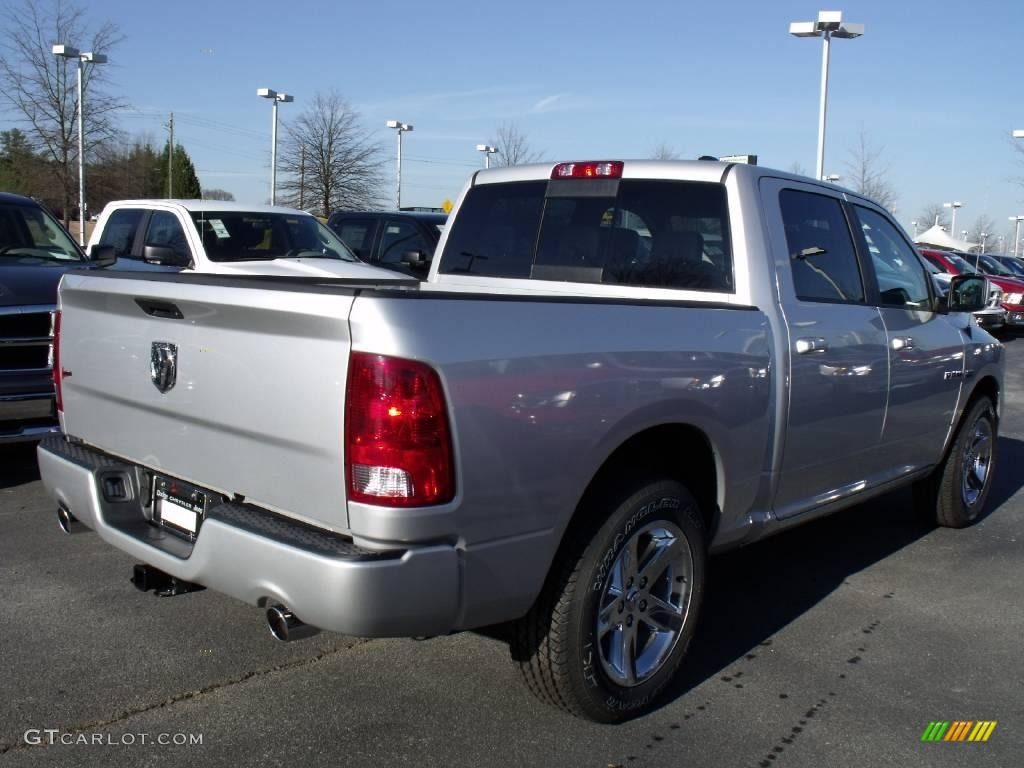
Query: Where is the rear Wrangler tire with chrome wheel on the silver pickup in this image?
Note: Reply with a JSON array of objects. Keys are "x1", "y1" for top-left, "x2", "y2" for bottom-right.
[{"x1": 511, "y1": 479, "x2": 706, "y2": 723}]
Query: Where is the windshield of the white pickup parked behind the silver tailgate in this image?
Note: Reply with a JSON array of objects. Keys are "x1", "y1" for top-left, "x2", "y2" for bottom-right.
[{"x1": 191, "y1": 211, "x2": 358, "y2": 261}]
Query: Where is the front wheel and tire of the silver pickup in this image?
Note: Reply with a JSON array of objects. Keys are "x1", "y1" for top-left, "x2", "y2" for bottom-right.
[{"x1": 914, "y1": 396, "x2": 998, "y2": 528}]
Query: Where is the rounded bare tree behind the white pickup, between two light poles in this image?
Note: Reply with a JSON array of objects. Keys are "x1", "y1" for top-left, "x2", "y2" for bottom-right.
[{"x1": 278, "y1": 91, "x2": 385, "y2": 216}]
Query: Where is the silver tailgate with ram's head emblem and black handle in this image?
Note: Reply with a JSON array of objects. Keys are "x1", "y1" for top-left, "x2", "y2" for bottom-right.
[{"x1": 60, "y1": 274, "x2": 355, "y2": 532}]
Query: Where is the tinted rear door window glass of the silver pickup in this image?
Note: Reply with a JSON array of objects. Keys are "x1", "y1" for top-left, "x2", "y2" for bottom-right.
[{"x1": 779, "y1": 189, "x2": 864, "y2": 303}]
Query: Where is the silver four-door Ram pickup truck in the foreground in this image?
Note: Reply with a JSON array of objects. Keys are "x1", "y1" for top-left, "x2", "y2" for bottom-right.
[{"x1": 39, "y1": 162, "x2": 1004, "y2": 722}]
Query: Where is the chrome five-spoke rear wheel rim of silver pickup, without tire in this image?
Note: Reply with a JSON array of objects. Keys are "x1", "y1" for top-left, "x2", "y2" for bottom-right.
[{"x1": 596, "y1": 520, "x2": 693, "y2": 687}]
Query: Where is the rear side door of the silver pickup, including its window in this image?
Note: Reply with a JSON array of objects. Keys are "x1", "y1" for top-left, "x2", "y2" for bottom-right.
[{"x1": 761, "y1": 179, "x2": 889, "y2": 517}]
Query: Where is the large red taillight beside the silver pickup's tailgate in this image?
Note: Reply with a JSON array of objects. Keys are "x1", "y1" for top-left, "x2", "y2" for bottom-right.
[{"x1": 345, "y1": 352, "x2": 455, "y2": 507}]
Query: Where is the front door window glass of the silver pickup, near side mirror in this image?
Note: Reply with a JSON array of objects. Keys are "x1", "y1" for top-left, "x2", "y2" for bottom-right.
[{"x1": 854, "y1": 206, "x2": 932, "y2": 309}]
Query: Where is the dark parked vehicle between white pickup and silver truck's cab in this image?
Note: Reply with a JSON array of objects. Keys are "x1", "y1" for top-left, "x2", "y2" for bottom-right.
[{"x1": 328, "y1": 211, "x2": 447, "y2": 278}]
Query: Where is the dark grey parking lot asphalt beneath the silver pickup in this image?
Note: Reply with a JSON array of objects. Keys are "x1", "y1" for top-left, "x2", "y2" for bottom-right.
[{"x1": 0, "y1": 339, "x2": 1024, "y2": 768}]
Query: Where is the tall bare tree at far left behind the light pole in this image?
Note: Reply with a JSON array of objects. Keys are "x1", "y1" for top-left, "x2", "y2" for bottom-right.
[{"x1": 0, "y1": 0, "x2": 123, "y2": 224}]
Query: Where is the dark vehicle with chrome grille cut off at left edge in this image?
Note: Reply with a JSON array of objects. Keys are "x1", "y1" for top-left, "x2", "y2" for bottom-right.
[{"x1": 0, "y1": 193, "x2": 114, "y2": 443}]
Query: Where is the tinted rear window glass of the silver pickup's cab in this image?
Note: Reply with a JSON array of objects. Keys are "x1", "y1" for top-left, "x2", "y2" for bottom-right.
[{"x1": 440, "y1": 179, "x2": 733, "y2": 292}]
